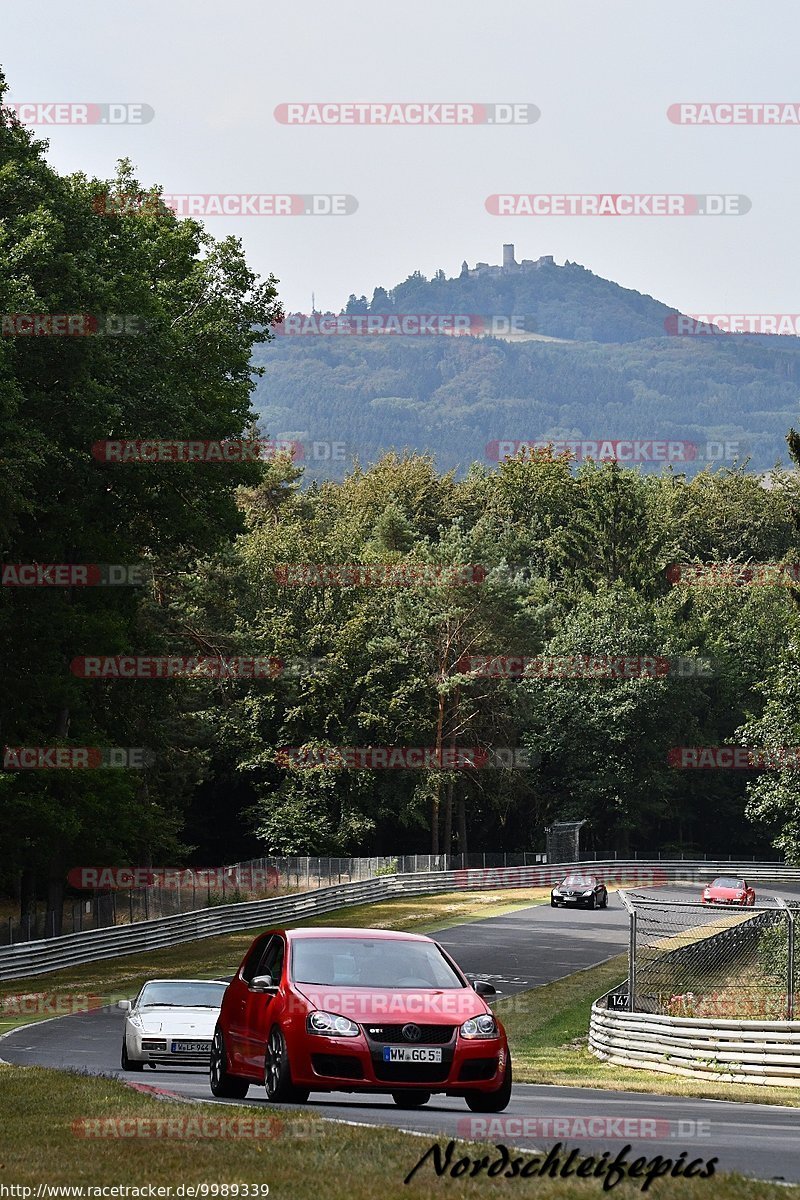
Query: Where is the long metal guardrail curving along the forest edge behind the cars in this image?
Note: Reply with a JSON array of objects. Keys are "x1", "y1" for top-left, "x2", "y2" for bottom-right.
[{"x1": 0, "y1": 859, "x2": 800, "y2": 980}]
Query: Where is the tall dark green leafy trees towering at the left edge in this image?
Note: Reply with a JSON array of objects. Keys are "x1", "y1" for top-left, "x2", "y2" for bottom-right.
[{"x1": 0, "y1": 78, "x2": 281, "y2": 925}]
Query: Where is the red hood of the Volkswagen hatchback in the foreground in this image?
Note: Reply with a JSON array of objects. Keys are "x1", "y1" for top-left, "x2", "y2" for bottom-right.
[{"x1": 291, "y1": 983, "x2": 491, "y2": 1025}]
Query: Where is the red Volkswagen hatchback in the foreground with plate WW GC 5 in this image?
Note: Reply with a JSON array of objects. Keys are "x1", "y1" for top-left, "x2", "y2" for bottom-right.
[{"x1": 210, "y1": 929, "x2": 511, "y2": 1112}]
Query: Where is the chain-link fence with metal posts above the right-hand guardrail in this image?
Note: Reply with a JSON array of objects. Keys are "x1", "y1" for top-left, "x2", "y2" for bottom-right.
[{"x1": 608, "y1": 893, "x2": 800, "y2": 1021}]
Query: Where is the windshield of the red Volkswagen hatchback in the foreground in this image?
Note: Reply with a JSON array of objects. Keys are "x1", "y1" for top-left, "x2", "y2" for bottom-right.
[{"x1": 291, "y1": 937, "x2": 464, "y2": 988}]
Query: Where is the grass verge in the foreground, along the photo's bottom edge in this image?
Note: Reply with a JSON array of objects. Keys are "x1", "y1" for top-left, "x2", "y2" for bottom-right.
[{"x1": 0, "y1": 1067, "x2": 800, "y2": 1200}]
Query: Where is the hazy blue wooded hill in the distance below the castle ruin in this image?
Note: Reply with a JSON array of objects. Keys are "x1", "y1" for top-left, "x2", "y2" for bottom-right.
[{"x1": 254, "y1": 248, "x2": 800, "y2": 478}]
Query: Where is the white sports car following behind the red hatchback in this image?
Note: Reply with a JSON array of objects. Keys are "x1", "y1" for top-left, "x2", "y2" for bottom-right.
[{"x1": 118, "y1": 979, "x2": 228, "y2": 1070}]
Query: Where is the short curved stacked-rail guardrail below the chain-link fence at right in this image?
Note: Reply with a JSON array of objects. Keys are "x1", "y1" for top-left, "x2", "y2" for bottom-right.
[{"x1": 589, "y1": 996, "x2": 800, "y2": 1087}]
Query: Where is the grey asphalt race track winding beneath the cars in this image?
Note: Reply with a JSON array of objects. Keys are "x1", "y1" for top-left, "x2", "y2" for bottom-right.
[{"x1": 0, "y1": 884, "x2": 800, "y2": 1182}]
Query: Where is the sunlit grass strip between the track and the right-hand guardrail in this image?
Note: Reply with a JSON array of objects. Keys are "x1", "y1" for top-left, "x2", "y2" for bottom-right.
[{"x1": 494, "y1": 954, "x2": 800, "y2": 1108}]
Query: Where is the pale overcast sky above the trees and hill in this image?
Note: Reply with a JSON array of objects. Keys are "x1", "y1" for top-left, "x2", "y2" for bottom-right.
[{"x1": 0, "y1": 0, "x2": 800, "y2": 313}]
